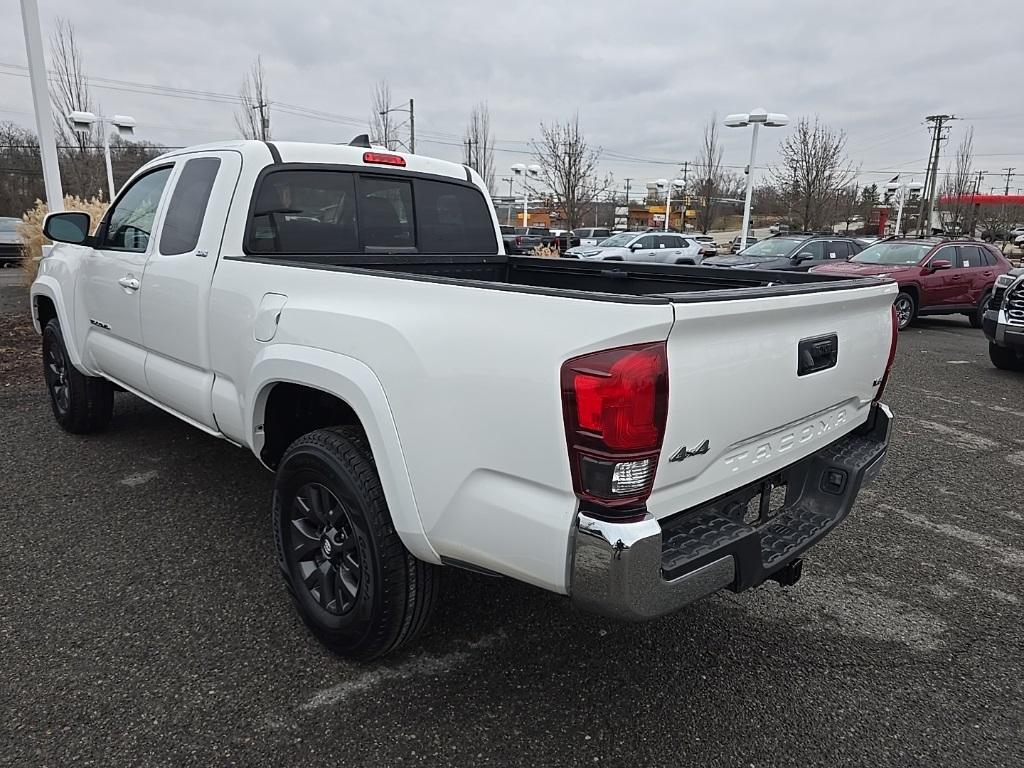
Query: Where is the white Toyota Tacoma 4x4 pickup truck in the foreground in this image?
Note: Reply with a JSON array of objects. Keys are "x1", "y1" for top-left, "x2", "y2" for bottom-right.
[{"x1": 31, "y1": 137, "x2": 896, "y2": 658}]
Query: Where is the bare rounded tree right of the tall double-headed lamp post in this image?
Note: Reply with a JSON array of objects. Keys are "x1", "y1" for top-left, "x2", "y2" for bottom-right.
[{"x1": 772, "y1": 117, "x2": 854, "y2": 230}]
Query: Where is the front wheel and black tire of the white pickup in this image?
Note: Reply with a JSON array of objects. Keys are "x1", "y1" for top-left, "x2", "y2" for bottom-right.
[{"x1": 43, "y1": 317, "x2": 114, "y2": 434}]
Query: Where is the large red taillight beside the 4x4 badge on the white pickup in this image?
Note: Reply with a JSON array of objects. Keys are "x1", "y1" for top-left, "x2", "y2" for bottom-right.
[{"x1": 561, "y1": 342, "x2": 669, "y2": 514}]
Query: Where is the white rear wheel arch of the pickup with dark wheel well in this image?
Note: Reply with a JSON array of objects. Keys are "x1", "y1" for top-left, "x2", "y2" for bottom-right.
[{"x1": 246, "y1": 344, "x2": 440, "y2": 563}]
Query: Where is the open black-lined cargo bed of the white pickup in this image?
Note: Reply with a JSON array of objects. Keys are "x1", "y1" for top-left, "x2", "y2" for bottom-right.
[{"x1": 239, "y1": 254, "x2": 877, "y2": 303}]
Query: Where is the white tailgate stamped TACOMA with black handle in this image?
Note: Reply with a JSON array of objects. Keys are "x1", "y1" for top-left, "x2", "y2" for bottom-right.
[{"x1": 647, "y1": 284, "x2": 897, "y2": 518}]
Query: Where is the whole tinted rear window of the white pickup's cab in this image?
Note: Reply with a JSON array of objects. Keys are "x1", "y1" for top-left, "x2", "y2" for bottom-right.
[{"x1": 247, "y1": 170, "x2": 498, "y2": 255}]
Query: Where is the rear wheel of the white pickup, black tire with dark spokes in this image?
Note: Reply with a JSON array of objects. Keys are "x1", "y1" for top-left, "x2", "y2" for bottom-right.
[{"x1": 273, "y1": 427, "x2": 440, "y2": 660}]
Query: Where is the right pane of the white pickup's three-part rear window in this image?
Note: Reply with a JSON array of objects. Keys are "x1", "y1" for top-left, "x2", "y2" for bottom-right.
[{"x1": 414, "y1": 179, "x2": 498, "y2": 253}]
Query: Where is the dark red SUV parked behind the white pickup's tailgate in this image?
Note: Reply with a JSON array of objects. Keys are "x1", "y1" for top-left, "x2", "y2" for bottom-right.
[{"x1": 811, "y1": 238, "x2": 1013, "y2": 330}]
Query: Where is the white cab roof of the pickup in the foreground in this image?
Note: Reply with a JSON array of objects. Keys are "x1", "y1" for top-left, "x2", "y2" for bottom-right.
[{"x1": 153, "y1": 140, "x2": 468, "y2": 183}]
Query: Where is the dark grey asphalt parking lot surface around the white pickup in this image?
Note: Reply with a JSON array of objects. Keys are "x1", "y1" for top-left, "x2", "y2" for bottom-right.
[{"x1": 0, "y1": 278, "x2": 1024, "y2": 767}]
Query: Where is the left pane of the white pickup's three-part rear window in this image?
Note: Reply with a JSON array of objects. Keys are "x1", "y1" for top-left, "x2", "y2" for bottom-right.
[{"x1": 247, "y1": 171, "x2": 359, "y2": 254}]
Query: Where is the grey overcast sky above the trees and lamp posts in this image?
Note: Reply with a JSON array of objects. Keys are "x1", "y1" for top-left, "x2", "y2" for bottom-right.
[{"x1": 0, "y1": 0, "x2": 1024, "y2": 198}]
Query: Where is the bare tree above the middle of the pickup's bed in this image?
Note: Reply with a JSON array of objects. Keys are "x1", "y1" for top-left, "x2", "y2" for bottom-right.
[{"x1": 532, "y1": 114, "x2": 611, "y2": 229}]
